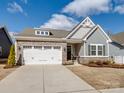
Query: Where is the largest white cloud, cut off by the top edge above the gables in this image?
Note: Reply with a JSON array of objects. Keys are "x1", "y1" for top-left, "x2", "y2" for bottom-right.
[{"x1": 63, "y1": 0, "x2": 111, "y2": 16}]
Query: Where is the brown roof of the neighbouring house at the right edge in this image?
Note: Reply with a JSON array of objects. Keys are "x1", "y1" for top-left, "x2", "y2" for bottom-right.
[{"x1": 111, "y1": 32, "x2": 124, "y2": 45}]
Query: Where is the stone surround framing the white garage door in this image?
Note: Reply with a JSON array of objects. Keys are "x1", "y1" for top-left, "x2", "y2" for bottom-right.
[{"x1": 16, "y1": 41, "x2": 67, "y2": 64}]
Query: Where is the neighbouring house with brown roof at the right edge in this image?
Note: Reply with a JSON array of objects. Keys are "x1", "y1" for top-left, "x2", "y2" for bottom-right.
[{"x1": 110, "y1": 32, "x2": 124, "y2": 64}]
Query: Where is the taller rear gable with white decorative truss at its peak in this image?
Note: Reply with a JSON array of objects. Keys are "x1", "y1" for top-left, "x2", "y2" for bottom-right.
[{"x1": 66, "y1": 17, "x2": 95, "y2": 39}]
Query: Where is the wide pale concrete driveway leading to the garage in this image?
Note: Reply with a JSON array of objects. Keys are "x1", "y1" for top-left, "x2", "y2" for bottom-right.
[{"x1": 0, "y1": 65, "x2": 98, "y2": 93}]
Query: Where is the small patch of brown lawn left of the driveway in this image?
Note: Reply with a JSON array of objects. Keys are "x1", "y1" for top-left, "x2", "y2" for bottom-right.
[{"x1": 0, "y1": 64, "x2": 16, "y2": 80}]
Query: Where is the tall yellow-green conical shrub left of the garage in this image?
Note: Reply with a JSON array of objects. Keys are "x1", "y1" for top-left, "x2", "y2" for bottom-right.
[{"x1": 4, "y1": 45, "x2": 15, "y2": 68}]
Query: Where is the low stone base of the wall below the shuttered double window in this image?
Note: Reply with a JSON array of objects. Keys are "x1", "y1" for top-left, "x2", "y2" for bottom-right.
[{"x1": 78, "y1": 57, "x2": 109, "y2": 64}]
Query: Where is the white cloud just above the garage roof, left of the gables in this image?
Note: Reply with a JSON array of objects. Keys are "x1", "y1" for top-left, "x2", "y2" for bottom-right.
[{"x1": 41, "y1": 14, "x2": 78, "y2": 30}]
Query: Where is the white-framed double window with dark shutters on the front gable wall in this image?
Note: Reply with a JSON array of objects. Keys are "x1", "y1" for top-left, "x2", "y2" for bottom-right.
[{"x1": 89, "y1": 44, "x2": 105, "y2": 56}]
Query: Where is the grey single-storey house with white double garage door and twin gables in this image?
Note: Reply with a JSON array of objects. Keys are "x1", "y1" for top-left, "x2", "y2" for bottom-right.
[{"x1": 15, "y1": 17, "x2": 123, "y2": 64}]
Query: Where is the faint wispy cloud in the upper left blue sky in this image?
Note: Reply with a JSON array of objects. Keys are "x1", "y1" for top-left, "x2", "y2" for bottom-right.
[{"x1": 7, "y1": 2, "x2": 27, "y2": 16}]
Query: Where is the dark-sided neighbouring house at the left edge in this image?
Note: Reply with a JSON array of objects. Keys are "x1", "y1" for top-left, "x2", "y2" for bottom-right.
[{"x1": 0, "y1": 27, "x2": 13, "y2": 58}]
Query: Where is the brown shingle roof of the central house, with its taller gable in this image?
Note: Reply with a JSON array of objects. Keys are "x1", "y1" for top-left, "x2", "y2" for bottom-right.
[{"x1": 16, "y1": 17, "x2": 111, "y2": 42}]
